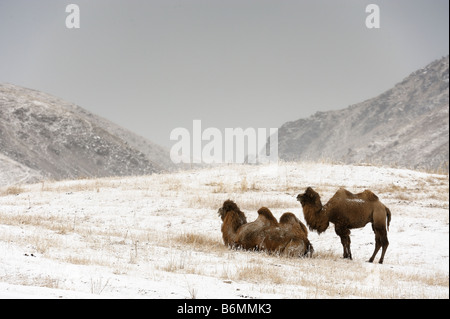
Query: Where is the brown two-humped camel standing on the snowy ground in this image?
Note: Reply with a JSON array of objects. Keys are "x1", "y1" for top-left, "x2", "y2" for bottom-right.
[{"x1": 297, "y1": 187, "x2": 391, "y2": 264}]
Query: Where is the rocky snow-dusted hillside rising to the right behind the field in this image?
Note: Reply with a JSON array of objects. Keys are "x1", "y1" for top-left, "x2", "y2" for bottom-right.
[{"x1": 278, "y1": 56, "x2": 449, "y2": 171}]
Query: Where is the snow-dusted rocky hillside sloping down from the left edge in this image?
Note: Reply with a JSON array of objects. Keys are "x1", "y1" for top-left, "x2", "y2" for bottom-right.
[{"x1": 0, "y1": 84, "x2": 171, "y2": 185}]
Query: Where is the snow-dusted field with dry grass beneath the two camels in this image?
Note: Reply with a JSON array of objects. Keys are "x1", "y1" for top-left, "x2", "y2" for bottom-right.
[{"x1": 0, "y1": 163, "x2": 449, "y2": 298}]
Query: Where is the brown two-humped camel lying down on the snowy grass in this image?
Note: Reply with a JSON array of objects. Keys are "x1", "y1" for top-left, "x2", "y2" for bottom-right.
[{"x1": 218, "y1": 200, "x2": 313, "y2": 257}]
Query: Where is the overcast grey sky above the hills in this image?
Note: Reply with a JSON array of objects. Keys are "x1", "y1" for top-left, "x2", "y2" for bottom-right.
[{"x1": 0, "y1": 0, "x2": 449, "y2": 146}]
